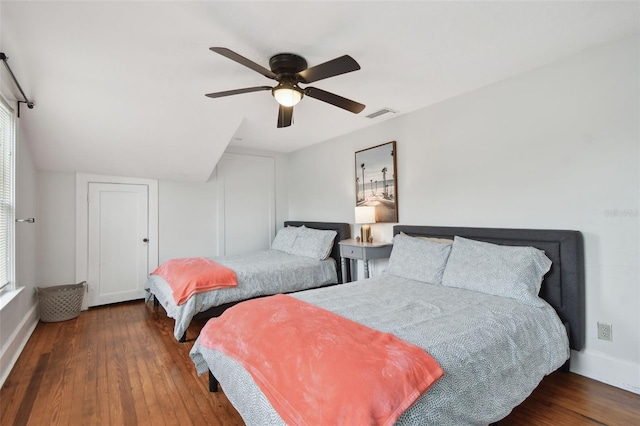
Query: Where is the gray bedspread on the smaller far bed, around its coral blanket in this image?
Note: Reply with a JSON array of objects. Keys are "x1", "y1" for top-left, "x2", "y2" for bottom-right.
[{"x1": 145, "y1": 250, "x2": 338, "y2": 340}]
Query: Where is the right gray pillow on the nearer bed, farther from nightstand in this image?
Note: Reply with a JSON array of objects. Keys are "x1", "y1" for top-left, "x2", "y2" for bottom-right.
[{"x1": 442, "y1": 237, "x2": 551, "y2": 306}]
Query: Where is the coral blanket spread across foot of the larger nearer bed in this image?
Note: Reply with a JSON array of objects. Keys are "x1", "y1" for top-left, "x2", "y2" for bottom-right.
[{"x1": 198, "y1": 294, "x2": 444, "y2": 425}]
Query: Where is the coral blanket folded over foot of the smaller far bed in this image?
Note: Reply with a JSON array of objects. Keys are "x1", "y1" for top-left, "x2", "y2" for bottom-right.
[{"x1": 151, "y1": 257, "x2": 238, "y2": 305}]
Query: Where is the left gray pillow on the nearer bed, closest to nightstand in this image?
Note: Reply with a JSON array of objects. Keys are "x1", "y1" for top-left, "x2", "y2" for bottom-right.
[{"x1": 387, "y1": 234, "x2": 451, "y2": 284}]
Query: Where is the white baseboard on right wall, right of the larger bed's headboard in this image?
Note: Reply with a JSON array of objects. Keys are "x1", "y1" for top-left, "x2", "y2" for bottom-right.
[{"x1": 571, "y1": 350, "x2": 640, "y2": 395}]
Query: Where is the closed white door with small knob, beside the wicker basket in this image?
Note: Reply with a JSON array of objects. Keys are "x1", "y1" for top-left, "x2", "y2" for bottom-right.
[{"x1": 87, "y1": 182, "x2": 149, "y2": 306}]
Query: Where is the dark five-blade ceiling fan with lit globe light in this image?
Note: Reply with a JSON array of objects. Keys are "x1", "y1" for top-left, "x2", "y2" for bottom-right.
[{"x1": 205, "y1": 47, "x2": 365, "y2": 127}]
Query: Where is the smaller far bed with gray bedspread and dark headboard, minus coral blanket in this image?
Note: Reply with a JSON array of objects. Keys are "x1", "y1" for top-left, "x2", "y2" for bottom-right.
[{"x1": 145, "y1": 221, "x2": 351, "y2": 342}]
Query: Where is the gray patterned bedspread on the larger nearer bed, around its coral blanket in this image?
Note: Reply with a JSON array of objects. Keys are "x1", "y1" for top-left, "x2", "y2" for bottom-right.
[{"x1": 190, "y1": 275, "x2": 570, "y2": 426}]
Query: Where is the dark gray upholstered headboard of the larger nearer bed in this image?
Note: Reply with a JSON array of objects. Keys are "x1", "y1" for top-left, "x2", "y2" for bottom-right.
[{"x1": 393, "y1": 225, "x2": 585, "y2": 350}]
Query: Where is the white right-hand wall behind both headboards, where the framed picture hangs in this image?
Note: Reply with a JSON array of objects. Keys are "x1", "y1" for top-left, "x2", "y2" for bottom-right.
[{"x1": 289, "y1": 37, "x2": 640, "y2": 393}]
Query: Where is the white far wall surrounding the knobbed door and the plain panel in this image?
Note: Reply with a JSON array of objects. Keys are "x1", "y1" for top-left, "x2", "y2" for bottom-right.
[{"x1": 36, "y1": 149, "x2": 288, "y2": 286}]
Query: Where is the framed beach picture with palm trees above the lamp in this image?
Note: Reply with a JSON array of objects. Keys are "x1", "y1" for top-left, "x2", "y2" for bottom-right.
[{"x1": 355, "y1": 141, "x2": 398, "y2": 223}]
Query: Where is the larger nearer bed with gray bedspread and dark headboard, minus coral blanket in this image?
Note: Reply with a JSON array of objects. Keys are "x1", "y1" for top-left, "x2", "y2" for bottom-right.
[{"x1": 190, "y1": 225, "x2": 585, "y2": 425}]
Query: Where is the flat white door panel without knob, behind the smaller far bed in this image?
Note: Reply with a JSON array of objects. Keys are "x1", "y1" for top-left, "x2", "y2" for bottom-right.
[{"x1": 216, "y1": 154, "x2": 275, "y2": 255}]
